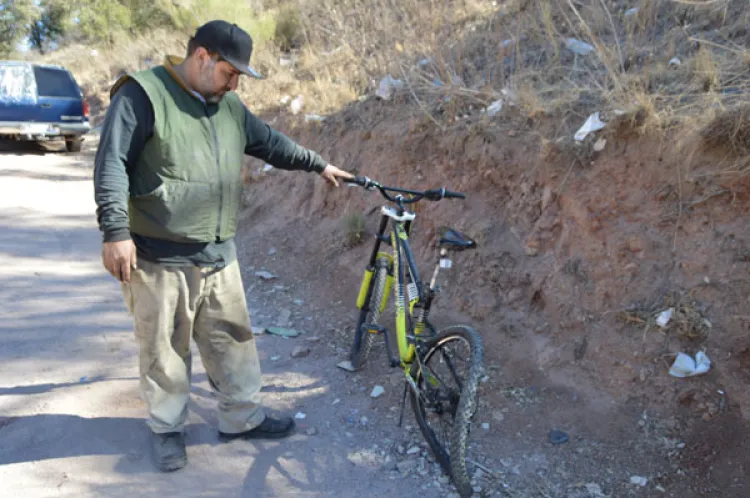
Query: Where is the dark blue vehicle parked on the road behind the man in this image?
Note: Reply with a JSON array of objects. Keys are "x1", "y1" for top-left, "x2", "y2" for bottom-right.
[{"x1": 0, "y1": 61, "x2": 91, "y2": 152}]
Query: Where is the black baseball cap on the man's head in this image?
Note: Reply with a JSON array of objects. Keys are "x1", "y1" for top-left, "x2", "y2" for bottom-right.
[{"x1": 193, "y1": 20, "x2": 263, "y2": 79}]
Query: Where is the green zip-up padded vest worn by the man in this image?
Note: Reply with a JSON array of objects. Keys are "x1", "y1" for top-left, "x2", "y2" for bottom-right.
[{"x1": 116, "y1": 66, "x2": 246, "y2": 242}]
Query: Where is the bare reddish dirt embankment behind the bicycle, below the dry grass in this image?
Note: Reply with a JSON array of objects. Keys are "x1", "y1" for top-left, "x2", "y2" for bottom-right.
[{"x1": 238, "y1": 96, "x2": 750, "y2": 496}]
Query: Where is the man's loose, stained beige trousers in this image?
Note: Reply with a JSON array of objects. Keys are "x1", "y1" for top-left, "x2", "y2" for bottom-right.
[{"x1": 122, "y1": 260, "x2": 265, "y2": 433}]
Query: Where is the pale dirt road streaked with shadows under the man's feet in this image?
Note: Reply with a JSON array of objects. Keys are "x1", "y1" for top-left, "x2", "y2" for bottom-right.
[{"x1": 0, "y1": 141, "x2": 464, "y2": 498}]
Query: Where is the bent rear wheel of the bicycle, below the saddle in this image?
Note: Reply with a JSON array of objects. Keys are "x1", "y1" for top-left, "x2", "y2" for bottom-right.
[{"x1": 411, "y1": 326, "x2": 484, "y2": 496}]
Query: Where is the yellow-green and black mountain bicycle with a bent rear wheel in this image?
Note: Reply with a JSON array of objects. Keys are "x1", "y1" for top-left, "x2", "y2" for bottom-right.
[{"x1": 345, "y1": 176, "x2": 484, "y2": 496}]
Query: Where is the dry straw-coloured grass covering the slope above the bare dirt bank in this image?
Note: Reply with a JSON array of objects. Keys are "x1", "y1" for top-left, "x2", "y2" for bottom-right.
[{"x1": 32, "y1": 0, "x2": 750, "y2": 141}]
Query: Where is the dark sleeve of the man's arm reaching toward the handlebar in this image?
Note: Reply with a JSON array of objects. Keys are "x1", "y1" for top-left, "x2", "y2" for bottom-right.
[{"x1": 245, "y1": 108, "x2": 328, "y2": 173}]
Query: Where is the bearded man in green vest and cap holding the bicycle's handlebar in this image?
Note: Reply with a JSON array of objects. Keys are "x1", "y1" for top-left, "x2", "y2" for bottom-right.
[{"x1": 94, "y1": 21, "x2": 352, "y2": 471}]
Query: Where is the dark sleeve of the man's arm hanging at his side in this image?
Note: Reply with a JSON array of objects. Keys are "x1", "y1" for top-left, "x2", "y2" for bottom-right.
[{"x1": 94, "y1": 80, "x2": 154, "y2": 242}]
